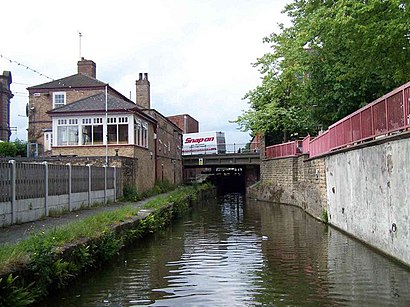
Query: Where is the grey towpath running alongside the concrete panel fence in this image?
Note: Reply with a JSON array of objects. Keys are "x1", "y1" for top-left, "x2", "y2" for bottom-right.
[{"x1": 0, "y1": 193, "x2": 169, "y2": 247}]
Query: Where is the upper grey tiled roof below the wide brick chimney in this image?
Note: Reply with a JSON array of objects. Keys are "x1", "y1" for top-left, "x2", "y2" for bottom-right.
[{"x1": 28, "y1": 73, "x2": 106, "y2": 90}]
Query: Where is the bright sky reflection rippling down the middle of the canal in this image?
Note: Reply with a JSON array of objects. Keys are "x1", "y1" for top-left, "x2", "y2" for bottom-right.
[{"x1": 153, "y1": 194, "x2": 263, "y2": 306}]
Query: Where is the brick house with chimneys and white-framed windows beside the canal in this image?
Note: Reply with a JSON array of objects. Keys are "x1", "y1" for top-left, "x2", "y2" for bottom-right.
[{"x1": 28, "y1": 59, "x2": 182, "y2": 190}]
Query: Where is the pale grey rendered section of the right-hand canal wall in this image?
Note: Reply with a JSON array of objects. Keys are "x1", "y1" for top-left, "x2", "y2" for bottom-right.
[{"x1": 326, "y1": 139, "x2": 410, "y2": 265}]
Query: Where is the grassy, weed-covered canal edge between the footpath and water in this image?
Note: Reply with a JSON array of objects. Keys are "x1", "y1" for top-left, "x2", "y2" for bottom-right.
[{"x1": 0, "y1": 185, "x2": 215, "y2": 306}]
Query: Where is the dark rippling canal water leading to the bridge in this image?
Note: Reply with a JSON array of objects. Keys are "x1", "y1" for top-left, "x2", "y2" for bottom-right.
[{"x1": 42, "y1": 193, "x2": 410, "y2": 307}]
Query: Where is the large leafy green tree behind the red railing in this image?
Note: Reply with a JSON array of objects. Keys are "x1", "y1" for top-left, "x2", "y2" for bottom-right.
[{"x1": 235, "y1": 0, "x2": 410, "y2": 145}]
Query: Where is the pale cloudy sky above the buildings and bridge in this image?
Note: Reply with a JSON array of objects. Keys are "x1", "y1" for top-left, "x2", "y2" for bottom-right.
[{"x1": 0, "y1": 0, "x2": 291, "y2": 144}]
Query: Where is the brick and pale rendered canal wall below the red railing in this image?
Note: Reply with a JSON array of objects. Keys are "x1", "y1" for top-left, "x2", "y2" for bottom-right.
[{"x1": 248, "y1": 133, "x2": 410, "y2": 266}]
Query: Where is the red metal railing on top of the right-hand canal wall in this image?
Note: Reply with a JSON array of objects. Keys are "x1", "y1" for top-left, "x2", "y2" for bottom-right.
[{"x1": 266, "y1": 82, "x2": 410, "y2": 158}]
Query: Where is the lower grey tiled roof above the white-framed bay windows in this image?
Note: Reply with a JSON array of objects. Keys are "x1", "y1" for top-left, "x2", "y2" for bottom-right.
[{"x1": 49, "y1": 93, "x2": 138, "y2": 114}]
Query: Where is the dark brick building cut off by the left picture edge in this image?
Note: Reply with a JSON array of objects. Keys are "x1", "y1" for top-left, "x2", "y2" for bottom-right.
[{"x1": 0, "y1": 71, "x2": 13, "y2": 142}]
